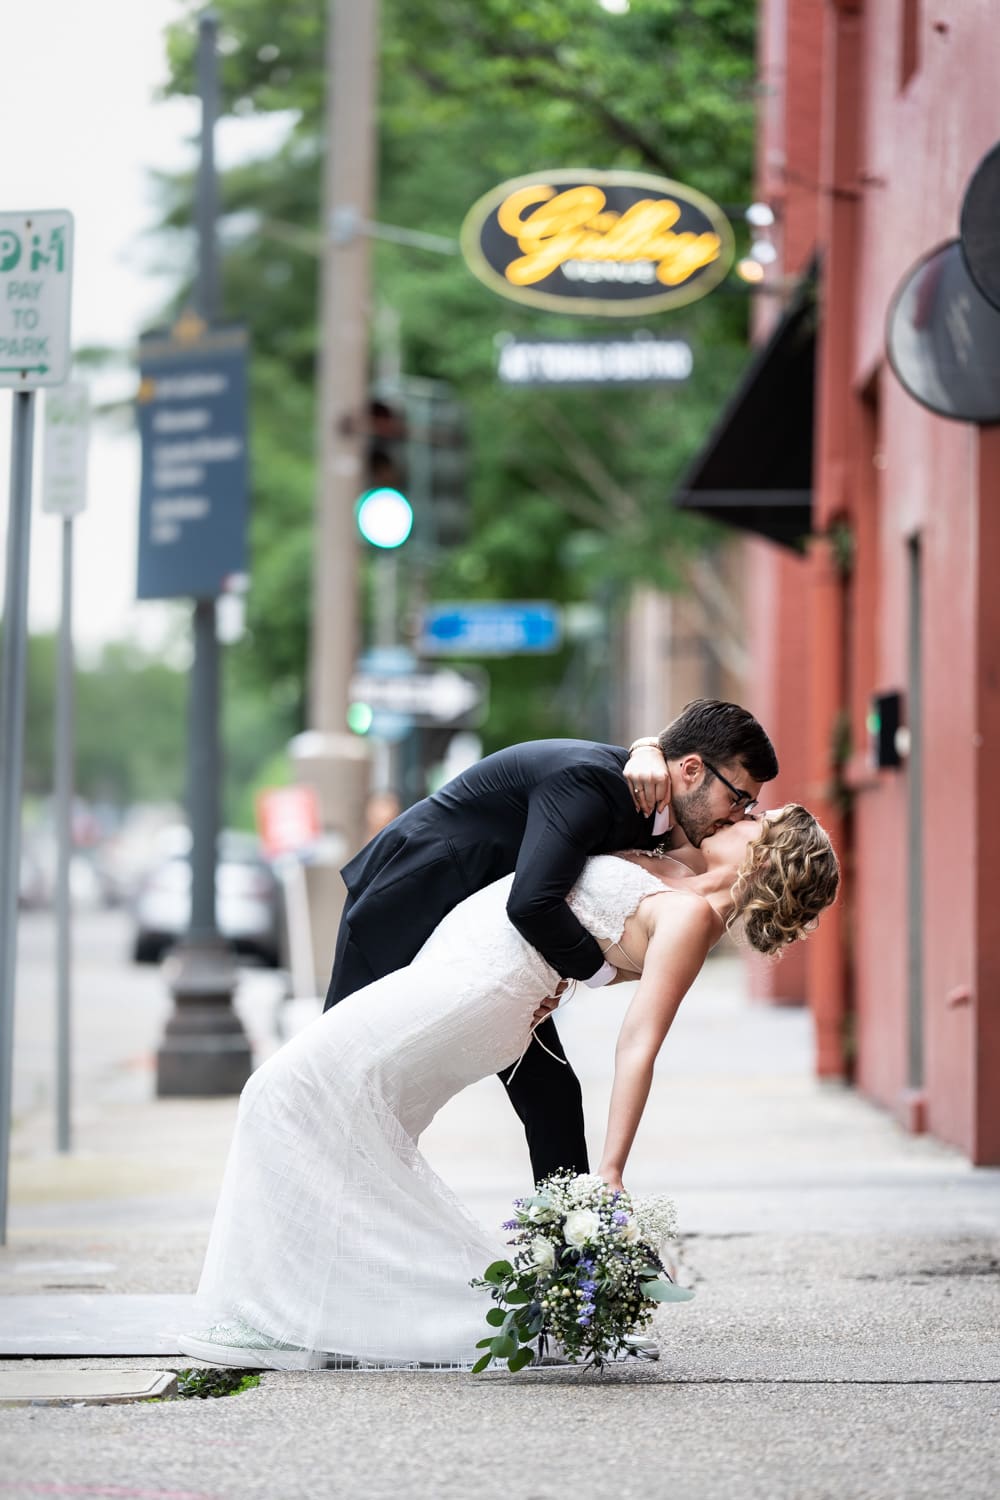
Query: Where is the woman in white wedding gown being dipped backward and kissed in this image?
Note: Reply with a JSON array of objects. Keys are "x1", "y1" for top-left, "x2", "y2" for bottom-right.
[{"x1": 180, "y1": 804, "x2": 838, "y2": 1370}]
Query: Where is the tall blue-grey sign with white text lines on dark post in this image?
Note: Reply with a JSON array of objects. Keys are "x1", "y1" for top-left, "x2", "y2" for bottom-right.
[{"x1": 136, "y1": 320, "x2": 249, "y2": 599}]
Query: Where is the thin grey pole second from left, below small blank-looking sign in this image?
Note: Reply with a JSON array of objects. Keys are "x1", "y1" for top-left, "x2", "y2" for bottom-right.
[{"x1": 55, "y1": 516, "x2": 75, "y2": 1152}]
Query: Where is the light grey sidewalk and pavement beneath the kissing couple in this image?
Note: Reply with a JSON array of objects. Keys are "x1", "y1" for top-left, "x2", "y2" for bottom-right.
[{"x1": 0, "y1": 914, "x2": 1000, "y2": 1500}]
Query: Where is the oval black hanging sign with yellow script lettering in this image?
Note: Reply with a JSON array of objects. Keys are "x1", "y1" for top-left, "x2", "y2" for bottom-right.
[{"x1": 462, "y1": 170, "x2": 733, "y2": 318}]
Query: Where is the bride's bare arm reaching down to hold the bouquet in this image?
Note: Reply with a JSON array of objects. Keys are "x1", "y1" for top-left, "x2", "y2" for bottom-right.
[{"x1": 597, "y1": 893, "x2": 718, "y2": 1188}]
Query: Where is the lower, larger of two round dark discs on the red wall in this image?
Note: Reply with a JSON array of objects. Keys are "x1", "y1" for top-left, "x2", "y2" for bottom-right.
[{"x1": 886, "y1": 240, "x2": 1000, "y2": 425}]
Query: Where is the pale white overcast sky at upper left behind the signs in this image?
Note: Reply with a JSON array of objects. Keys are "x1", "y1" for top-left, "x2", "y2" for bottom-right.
[{"x1": 0, "y1": 0, "x2": 293, "y2": 650}]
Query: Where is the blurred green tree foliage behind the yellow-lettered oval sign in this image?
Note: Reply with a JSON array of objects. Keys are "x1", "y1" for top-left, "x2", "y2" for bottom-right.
[{"x1": 166, "y1": 0, "x2": 756, "y2": 743}]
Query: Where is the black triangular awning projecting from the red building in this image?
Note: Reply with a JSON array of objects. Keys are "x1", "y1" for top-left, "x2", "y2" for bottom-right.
[{"x1": 673, "y1": 276, "x2": 816, "y2": 549}]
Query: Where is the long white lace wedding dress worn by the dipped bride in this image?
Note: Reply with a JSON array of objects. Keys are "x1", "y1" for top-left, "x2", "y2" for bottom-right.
[{"x1": 188, "y1": 855, "x2": 664, "y2": 1367}]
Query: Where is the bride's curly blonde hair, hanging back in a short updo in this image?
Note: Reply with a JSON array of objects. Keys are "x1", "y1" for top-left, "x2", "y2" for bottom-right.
[{"x1": 726, "y1": 803, "x2": 840, "y2": 954}]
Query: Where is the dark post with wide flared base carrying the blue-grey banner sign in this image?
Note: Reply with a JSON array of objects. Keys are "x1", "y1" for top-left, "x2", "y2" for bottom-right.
[{"x1": 156, "y1": 12, "x2": 252, "y2": 1098}]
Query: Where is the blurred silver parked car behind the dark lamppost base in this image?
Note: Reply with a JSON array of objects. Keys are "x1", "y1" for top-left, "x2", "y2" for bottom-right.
[{"x1": 132, "y1": 830, "x2": 282, "y2": 968}]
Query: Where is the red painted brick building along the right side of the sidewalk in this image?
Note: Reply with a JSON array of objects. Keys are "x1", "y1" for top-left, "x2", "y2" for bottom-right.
[{"x1": 679, "y1": 0, "x2": 1000, "y2": 1163}]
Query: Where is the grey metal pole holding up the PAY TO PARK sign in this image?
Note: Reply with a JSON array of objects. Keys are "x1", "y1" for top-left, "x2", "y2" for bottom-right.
[{"x1": 0, "y1": 390, "x2": 34, "y2": 1245}]
